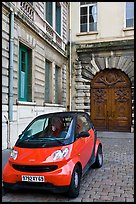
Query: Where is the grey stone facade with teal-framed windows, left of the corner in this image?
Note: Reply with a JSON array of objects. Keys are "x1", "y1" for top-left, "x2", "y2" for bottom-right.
[{"x1": 2, "y1": 2, "x2": 69, "y2": 149}]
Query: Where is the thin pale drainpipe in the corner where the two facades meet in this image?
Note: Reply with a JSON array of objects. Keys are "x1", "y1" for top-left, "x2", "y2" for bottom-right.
[{"x1": 69, "y1": 2, "x2": 71, "y2": 111}]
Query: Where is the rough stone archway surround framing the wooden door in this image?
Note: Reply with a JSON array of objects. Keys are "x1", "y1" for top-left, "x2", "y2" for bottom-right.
[{"x1": 72, "y1": 48, "x2": 134, "y2": 132}]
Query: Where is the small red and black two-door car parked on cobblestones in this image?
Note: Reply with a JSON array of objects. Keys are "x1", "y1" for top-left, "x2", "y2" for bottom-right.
[{"x1": 3, "y1": 111, "x2": 103, "y2": 198}]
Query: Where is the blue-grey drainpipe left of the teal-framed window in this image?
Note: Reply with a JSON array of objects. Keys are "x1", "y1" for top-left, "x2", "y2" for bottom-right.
[{"x1": 7, "y1": 10, "x2": 14, "y2": 148}]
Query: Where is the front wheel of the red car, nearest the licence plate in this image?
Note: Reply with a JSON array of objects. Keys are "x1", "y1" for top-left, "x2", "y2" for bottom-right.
[{"x1": 68, "y1": 165, "x2": 81, "y2": 198}]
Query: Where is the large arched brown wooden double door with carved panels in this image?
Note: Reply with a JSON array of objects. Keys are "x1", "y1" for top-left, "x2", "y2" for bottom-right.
[{"x1": 91, "y1": 69, "x2": 131, "y2": 132}]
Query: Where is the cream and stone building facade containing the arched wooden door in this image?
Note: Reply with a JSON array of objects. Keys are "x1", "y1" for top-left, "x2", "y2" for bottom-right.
[{"x1": 71, "y1": 2, "x2": 134, "y2": 132}]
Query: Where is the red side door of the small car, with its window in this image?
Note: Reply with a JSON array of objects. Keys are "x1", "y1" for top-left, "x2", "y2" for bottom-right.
[{"x1": 76, "y1": 114, "x2": 94, "y2": 167}]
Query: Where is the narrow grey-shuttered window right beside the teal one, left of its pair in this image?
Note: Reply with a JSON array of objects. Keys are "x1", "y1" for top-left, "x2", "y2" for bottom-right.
[{"x1": 45, "y1": 60, "x2": 52, "y2": 103}]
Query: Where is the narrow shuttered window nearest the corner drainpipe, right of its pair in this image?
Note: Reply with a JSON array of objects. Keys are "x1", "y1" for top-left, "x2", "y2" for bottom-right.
[{"x1": 55, "y1": 65, "x2": 61, "y2": 104}]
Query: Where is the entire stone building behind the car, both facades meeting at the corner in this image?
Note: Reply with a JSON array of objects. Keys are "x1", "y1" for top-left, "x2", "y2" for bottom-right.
[{"x1": 2, "y1": 2, "x2": 134, "y2": 149}]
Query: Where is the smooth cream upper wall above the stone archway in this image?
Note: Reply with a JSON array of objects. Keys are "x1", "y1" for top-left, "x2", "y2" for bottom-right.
[{"x1": 71, "y1": 2, "x2": 134, "y2": 42}]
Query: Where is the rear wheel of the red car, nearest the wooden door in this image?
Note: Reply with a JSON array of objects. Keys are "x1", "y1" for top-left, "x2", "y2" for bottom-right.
[{"x1": 92, "y1": 145, "x2": 103, "y2": 168}]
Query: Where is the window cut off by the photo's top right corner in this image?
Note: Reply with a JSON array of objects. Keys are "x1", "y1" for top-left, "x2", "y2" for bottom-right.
[{"x1": 126, "y1": 2, "x2": 134, "y2": 27}]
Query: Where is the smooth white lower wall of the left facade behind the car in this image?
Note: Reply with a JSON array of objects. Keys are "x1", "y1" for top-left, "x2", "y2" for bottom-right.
[{"x1": 2, "y1": 105, "x2": 66, "y2": 150}]
